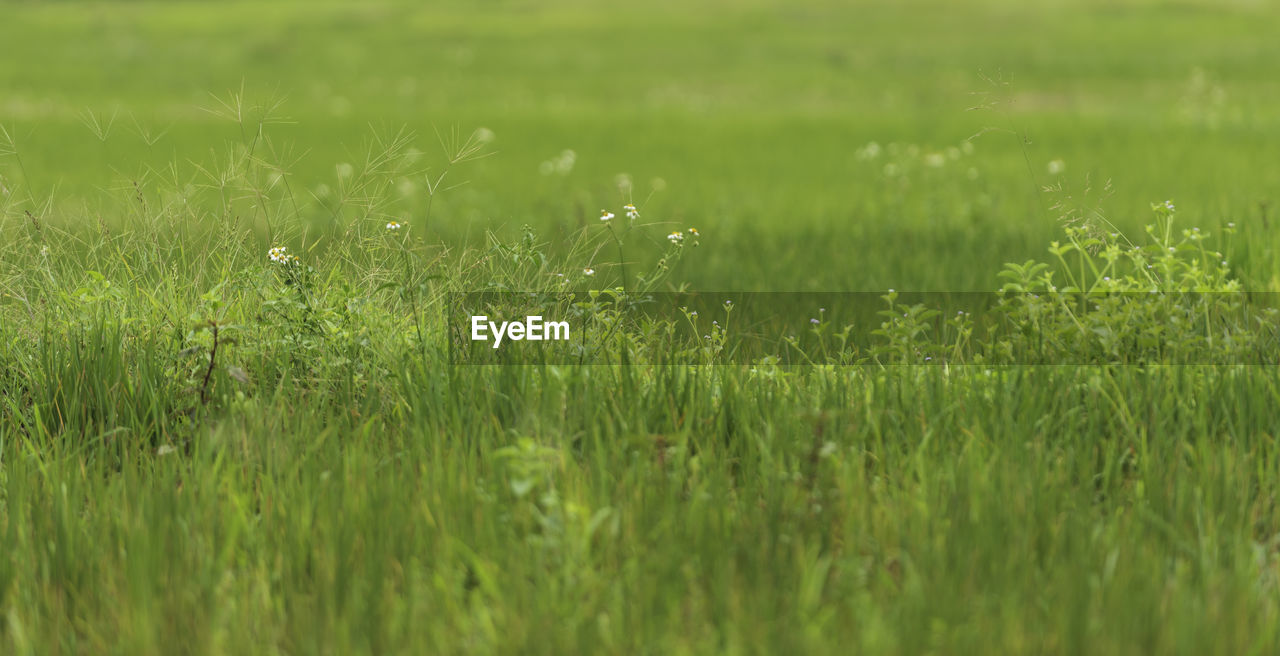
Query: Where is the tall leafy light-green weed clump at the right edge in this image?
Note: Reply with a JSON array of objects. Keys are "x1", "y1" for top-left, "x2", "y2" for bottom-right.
[{"x1": 996, "y1": 201, "x2": 1277, "y2": 364}]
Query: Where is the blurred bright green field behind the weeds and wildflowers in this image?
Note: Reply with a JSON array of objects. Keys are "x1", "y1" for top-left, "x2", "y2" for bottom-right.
[{"x1": 0, "y1": 0, "x2": 1280, "y2": 291}]
